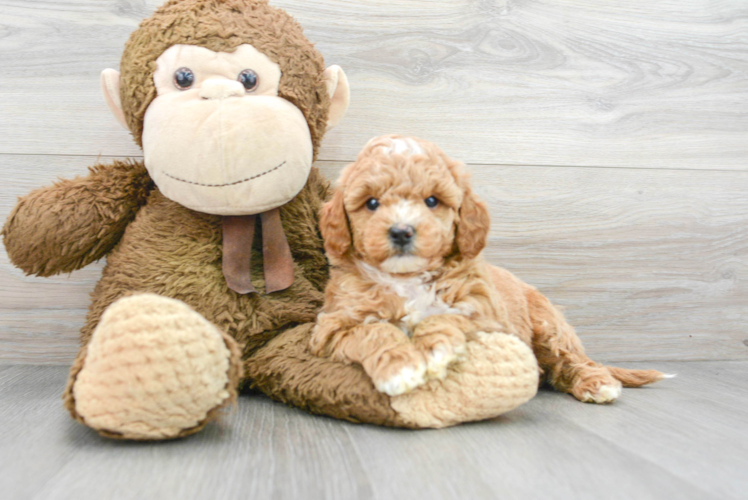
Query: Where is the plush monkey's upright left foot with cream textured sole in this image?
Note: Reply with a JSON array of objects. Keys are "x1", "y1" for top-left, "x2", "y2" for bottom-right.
[{"x1": 66, "y1": 294, "x2": 241, "y2": 439}]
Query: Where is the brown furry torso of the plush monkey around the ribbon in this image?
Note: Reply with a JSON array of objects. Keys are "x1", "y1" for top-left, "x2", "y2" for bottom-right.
[{"x1": 82, "y1": 186, "x2": 324, "y2": 356}]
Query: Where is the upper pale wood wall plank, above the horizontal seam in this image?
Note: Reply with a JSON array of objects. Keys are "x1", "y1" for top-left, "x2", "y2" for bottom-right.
[{"x1": 0, "y1": 0, "x2": 748, "y2": 170}]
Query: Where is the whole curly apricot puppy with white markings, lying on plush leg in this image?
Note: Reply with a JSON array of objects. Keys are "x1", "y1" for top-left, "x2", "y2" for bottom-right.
[{"x1": 312, "y1": 136, "x2": 663, "y2": 403}]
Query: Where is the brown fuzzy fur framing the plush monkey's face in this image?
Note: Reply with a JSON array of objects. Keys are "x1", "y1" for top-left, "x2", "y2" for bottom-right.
[{"x1": 120, "y1": 0, "x2": 330, "y2": 158}]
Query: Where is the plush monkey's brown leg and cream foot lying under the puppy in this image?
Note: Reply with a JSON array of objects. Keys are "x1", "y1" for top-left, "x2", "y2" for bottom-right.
[{"x1": 245, "y1": 323, "x2": 539, "y2": 428}]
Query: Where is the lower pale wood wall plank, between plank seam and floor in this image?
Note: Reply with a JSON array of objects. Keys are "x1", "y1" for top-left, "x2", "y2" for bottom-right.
[{"x1": 0, "y1": 155, "x2": 748, "y2": 364}]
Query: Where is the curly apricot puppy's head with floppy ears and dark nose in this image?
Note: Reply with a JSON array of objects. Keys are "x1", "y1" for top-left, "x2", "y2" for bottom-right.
[{"x1": 320, "y1": 135, "x2": 489, "y2": 274}]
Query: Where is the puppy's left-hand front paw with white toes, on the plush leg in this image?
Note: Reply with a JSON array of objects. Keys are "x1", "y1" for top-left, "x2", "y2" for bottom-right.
[{"x1": 364, "y1": 344, "x2": 427, "y2": 396}]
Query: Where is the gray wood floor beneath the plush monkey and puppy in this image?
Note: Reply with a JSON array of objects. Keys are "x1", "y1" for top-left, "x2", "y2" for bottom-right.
[{"x1": 0, "y1": 361, "x2": 748, "y2": 500}]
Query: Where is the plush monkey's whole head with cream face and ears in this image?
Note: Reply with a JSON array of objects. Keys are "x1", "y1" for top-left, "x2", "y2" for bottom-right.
[{"x1": 102, "y1": 0, "x2": 349, "y2": 216}]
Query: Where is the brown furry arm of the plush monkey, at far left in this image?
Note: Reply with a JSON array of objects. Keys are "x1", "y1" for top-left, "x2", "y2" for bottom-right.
[{"x1": 2, "y1": 160, "x2": 153, "y2": 276}]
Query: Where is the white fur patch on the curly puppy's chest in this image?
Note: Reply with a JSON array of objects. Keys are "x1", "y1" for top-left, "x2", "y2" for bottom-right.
[{"x1": 359, "y1": 263, "x2": 471, "y2": 335}]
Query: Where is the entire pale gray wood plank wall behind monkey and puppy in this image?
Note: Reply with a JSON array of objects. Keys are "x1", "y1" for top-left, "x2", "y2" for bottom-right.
[{"x1": 0, "y1": 0, "x2": 748, "y2": 364}]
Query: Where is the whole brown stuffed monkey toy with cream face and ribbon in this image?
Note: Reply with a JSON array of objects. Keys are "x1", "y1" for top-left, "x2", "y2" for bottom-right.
[{"x1": 2, "y1": 0, "x2": 538, "y2": 440}]
